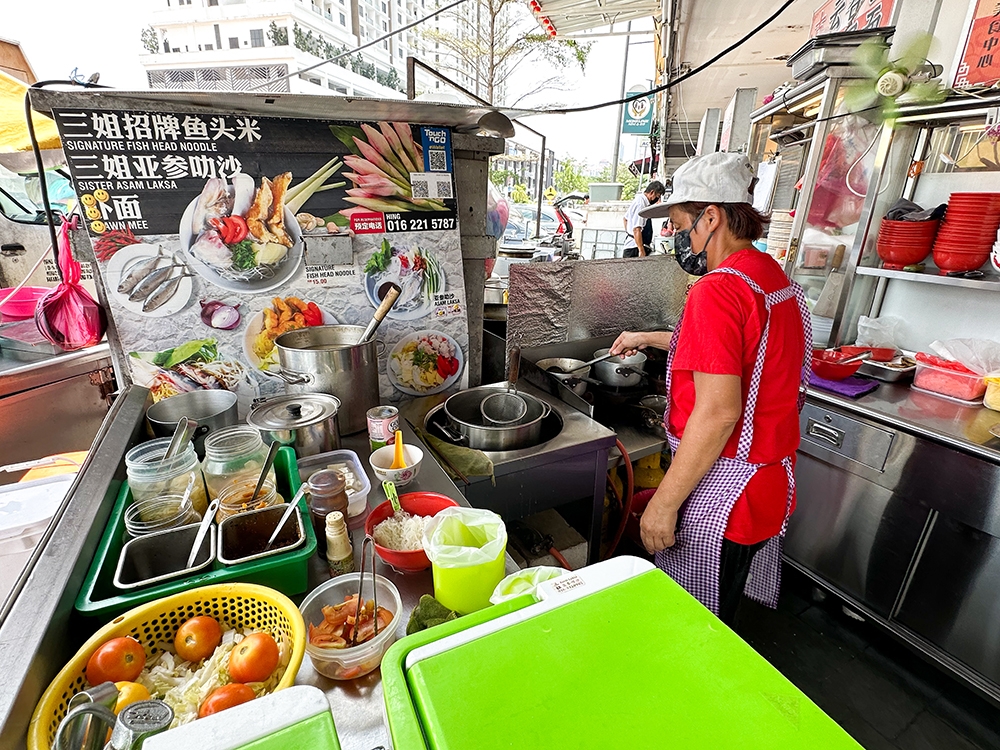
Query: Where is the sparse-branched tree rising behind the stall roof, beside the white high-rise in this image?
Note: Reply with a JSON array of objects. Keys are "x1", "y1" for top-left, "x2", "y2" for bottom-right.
[{"x1": 424, "y1": 0, "x2": 590, "y2": 106}]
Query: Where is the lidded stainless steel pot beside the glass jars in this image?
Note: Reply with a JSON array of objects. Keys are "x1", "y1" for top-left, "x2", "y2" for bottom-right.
[{"x1": 247, "y1": 393, "x2": 340, "y2": 458}]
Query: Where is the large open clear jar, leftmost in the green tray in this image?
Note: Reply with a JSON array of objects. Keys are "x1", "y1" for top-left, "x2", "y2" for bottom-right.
[{"x1": 125, "y1": 438, "x2": 208, "y2": 515}]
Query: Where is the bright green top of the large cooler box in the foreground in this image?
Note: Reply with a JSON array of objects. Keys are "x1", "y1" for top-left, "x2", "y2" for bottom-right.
[{"x1": 402, "y1": 570, "x2": 860, "y2": 750}]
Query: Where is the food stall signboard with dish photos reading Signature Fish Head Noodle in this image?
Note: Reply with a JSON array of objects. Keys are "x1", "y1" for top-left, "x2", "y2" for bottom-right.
[{"x1": 54, "y1": 109, "x2": 469, "y2": 413}]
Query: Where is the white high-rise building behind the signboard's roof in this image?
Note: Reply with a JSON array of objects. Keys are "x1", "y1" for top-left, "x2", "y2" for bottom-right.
[{"x1": 141, "y1": 0, "x2": 480, "y2": 98}]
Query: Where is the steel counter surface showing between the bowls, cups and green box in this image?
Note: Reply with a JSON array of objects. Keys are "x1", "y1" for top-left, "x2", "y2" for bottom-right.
[{"x1": 295, "y1": 421, "x2": 517, "y2": 750}]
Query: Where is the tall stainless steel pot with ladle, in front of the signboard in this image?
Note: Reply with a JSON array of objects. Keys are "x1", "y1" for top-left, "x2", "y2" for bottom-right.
[{"x1": 274, "y1": 326, "x2": 384, "y2": 435}]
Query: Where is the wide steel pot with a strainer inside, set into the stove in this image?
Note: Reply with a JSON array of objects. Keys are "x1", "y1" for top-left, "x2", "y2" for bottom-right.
[{"x1": 433, "y1": 386, "x2": 552, "y2": 451}]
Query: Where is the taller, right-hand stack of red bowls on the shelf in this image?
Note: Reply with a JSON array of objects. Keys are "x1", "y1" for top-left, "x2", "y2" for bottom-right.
[{"x1": 934, "y1": 193, "x2": 1000, "y2": 273}]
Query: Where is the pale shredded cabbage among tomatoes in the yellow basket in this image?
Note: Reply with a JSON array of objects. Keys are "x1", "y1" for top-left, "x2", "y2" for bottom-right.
[{"x1": 136, "y1": 629, "x2": 292, "y2": 728}]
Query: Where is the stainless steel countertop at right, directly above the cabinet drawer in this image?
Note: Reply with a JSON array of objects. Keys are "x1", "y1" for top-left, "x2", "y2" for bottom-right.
[{"x1": 809, "y1": 383, "x2": 1000, "y2": 464}]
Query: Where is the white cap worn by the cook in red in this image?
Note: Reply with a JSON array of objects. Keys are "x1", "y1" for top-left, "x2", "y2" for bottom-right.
[{"x1": 639, "y1": 151, "x2": 754, "y2": 219}]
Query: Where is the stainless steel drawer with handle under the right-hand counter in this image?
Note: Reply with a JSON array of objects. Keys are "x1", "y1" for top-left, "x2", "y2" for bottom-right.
[{"x1": 799, "y1": 404, "x2": 895, "y2": 471}]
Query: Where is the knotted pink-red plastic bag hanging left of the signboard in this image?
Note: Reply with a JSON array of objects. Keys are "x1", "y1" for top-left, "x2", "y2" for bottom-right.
[{"x1": 35, "y1": 216, "x2": 108, "y2": 351}]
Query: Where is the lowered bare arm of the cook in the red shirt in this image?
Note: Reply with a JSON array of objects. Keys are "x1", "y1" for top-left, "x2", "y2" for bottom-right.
[{"x1": 641, "y1": 372, "x2": 743, "y2": 553}]
